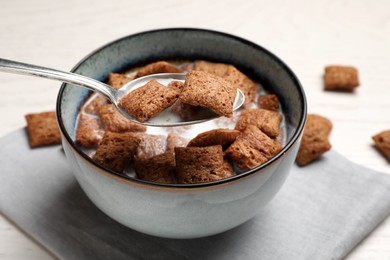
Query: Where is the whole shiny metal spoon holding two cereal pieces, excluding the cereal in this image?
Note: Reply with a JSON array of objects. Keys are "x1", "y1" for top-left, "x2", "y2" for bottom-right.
[{"x1": 0, "y1": 58, "x2": 245, "y2": 127}]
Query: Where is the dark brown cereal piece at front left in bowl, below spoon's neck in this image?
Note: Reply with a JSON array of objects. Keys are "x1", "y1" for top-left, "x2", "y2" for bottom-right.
[{"x1": 92, "y1": 132, "x2": 140, "y2": 173}]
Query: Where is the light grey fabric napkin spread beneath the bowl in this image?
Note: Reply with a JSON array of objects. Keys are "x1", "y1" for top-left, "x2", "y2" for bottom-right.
[{"x1": 0, "y1": 129, "x2": 390, "y2": 260}]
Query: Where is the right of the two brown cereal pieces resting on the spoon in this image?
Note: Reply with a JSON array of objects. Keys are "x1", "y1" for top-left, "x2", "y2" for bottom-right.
[{"x1": 179, "y1": 71, "x2": 236, "y2": 117}]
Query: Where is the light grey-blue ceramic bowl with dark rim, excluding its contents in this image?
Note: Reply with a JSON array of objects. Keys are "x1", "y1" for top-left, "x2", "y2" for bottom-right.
[{"x1": 57, "y1": 28, "x2": 306, "y2": 238}]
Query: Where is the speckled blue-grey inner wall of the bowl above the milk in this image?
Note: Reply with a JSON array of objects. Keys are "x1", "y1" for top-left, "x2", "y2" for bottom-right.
[{"x1": 57, "y1": 28, "x2": 306, "y2": 185}]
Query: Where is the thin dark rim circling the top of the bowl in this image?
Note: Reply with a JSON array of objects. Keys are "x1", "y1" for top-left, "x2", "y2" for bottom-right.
[{"x1": 56, "y1": 27, "x2": 307, "y2": 189}]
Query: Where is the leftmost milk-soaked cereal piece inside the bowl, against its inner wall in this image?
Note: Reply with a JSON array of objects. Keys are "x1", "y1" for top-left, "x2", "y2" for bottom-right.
[{"x1": 76, "y1": 114, "x2": 104, "y2": 148}]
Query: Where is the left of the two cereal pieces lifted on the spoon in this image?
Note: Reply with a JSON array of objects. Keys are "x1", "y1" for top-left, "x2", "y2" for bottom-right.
[{"x1": 119, "y1": 80, "x2": 181, "y2": 122}]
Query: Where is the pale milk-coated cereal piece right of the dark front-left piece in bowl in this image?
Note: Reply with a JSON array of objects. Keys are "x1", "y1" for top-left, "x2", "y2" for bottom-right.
[{"x1": 135, "y1": 134, "x2": 167, "y2": 160}]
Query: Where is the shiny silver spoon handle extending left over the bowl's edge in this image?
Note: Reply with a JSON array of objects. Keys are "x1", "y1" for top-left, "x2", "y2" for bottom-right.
[{"x1": 0, "y1": 58, "x2": 116, "y2": 103}]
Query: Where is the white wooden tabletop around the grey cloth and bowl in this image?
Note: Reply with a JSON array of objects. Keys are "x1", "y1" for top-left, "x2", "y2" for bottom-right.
[{"x1": 0, "y1": 0, "x2": 390, "y2": 260}]
